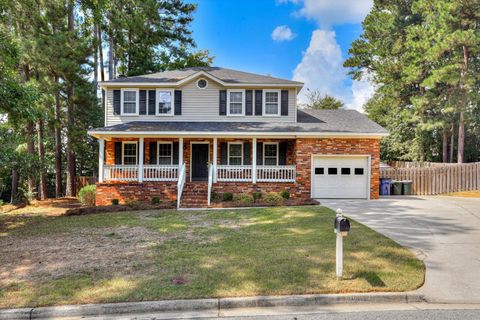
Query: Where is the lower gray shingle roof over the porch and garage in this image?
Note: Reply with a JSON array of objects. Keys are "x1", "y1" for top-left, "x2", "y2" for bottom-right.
[{"x1": 91, "y1": 110, "x2": 388, "y2": 135}]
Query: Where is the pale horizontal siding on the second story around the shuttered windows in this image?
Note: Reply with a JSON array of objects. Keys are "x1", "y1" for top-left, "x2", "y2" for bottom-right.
[{"x1": 105, "y1": 79, "x2": 297, "y2": 126}]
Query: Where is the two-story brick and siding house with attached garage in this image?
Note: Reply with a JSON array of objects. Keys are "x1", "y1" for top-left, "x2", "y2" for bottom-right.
[{"x1": 89, "y1": 67, "x2": 387, "y2": 207}]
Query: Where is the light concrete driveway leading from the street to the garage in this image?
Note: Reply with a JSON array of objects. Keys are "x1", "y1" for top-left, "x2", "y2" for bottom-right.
[{"x1": 320, "y1": 196, "x2": 480, "y2": 303}]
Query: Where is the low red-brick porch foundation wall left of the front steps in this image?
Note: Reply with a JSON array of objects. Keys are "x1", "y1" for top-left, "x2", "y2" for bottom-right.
[{"x1": 95, "y1": 181, "x2": 177, "y2": 206}]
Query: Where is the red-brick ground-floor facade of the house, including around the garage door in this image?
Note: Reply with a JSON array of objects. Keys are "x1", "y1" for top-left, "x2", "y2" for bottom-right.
[{"x1": 97, "y1": 138, "x2": 380, "y2": 205}]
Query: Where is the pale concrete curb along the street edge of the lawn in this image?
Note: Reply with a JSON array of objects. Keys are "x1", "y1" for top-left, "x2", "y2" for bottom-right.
[{"x1": 0, "y1": 292, "x2": 425, "y2": 320}]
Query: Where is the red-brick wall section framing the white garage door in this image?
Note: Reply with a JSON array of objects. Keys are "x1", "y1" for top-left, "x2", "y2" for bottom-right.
[{"x1": 296, "y1": 139, "x2": 380, "y2": 199}]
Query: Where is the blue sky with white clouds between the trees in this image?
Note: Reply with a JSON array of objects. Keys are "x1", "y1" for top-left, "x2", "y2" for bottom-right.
[{"x1": 188, "y1": 0, "x2": 374, "y2": 111}]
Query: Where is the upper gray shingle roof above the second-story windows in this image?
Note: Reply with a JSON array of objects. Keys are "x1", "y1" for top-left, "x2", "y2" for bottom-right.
[{"x1": 103, "y1": 67, "x2": 303, "y2": 85}]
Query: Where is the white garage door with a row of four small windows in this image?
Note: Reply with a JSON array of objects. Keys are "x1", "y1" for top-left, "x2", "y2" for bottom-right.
[{"x1": 312, "y1": 156, "x2": 370, "y2": 199}]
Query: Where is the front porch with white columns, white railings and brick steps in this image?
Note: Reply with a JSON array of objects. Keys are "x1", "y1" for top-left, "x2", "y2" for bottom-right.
[{"x1": 97, "y1": 137, "x2": 296, "y2": 207}]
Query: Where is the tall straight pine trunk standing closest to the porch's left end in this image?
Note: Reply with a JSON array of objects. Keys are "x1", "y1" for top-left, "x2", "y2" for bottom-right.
[{"x1": 65, "y1": 0, "x2": 75, "y2": 197}]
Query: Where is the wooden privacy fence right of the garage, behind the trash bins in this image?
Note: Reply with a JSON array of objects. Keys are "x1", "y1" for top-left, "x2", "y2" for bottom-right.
[{"x1": 380, "y1": 162, "x2": 480, "y2": 195}]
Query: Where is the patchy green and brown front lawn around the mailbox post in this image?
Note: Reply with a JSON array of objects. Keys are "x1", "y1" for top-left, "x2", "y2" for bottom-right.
[{"x1": 0, "y1": 206, "x2": 424, "y2": 308}]
